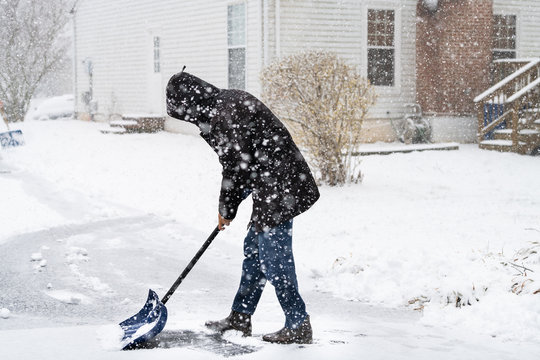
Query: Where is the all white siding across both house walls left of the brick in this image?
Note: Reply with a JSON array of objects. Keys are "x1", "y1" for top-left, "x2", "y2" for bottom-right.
[{"x1": 76, "y1": 0, "x2": 416, "y2": 139}]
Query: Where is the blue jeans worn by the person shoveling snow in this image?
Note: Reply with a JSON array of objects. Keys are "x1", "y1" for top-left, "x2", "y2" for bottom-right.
[{"x1": 232, "y1": 219, "x2": 308, "y2": 329}]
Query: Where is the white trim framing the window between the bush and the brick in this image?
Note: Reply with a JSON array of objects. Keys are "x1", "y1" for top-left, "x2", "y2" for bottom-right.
[{"x1": 361, "y1": 1, "x2": 402, "y2": 94}]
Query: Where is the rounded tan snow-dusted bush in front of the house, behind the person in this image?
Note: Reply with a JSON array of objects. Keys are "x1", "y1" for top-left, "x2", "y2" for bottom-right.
[{"x1": 261, "y1": 51, "x2": 375, "y2": 185}]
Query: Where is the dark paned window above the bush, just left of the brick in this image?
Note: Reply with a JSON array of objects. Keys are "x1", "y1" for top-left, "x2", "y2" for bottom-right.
[{"x1": 367, "y1": 9, "x2": 395, "y2": 86}]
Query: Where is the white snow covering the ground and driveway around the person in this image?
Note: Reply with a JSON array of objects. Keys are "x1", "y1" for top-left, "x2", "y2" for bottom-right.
[{"x1": 0, "y1": 121, "x2": 540, "y2": 359}]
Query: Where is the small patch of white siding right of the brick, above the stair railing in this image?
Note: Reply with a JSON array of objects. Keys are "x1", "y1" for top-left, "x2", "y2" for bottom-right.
[{"x1": 493, "y1": 0, "x2": 540, "y2": 58}]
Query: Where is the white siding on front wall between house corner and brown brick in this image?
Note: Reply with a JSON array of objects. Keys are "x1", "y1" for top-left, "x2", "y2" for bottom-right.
[{"x1": 279, "y1": 0, "x2": 416, "y2": 137}]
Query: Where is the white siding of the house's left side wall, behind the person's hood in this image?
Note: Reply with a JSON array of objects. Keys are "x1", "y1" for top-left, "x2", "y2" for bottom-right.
[{"x1": 76, "y1": 0, "x2": 262, "y2": 122}]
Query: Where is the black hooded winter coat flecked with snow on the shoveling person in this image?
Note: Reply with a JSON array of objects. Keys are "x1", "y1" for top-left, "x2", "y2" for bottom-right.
[{"x1": 167, "y1": 72, "x2": 319, "y2": 231}]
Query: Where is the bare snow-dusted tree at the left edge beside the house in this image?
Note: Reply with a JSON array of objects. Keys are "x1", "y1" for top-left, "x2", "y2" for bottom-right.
[{"x1": 0, "y1": 0, "x2": 69, "y2": 122}]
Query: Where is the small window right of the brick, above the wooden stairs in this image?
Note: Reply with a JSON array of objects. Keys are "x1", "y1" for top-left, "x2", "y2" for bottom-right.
[{"x1": 493, "y1": 15, "x2": 516, "y2": 60}]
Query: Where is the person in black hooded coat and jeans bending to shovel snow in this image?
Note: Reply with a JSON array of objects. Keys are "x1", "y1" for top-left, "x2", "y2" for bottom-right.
[{"x1": 167, "y1": 71, "x2": 319, "y2": 343}]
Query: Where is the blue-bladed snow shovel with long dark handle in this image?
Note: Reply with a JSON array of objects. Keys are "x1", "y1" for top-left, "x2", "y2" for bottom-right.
[{"x1": 119, "y1": 226, "x2": 219, "y2": 350}]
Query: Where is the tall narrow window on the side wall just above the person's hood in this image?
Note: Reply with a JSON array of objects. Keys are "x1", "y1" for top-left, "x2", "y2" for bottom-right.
[{"x1": 227, "y1": 3, "x2": 246, "y2": 89}]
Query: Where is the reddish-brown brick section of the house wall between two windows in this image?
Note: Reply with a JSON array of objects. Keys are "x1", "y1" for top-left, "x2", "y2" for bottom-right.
[{"x1": 416, "y1": 0, "x2": 493, "y2": 115}]
